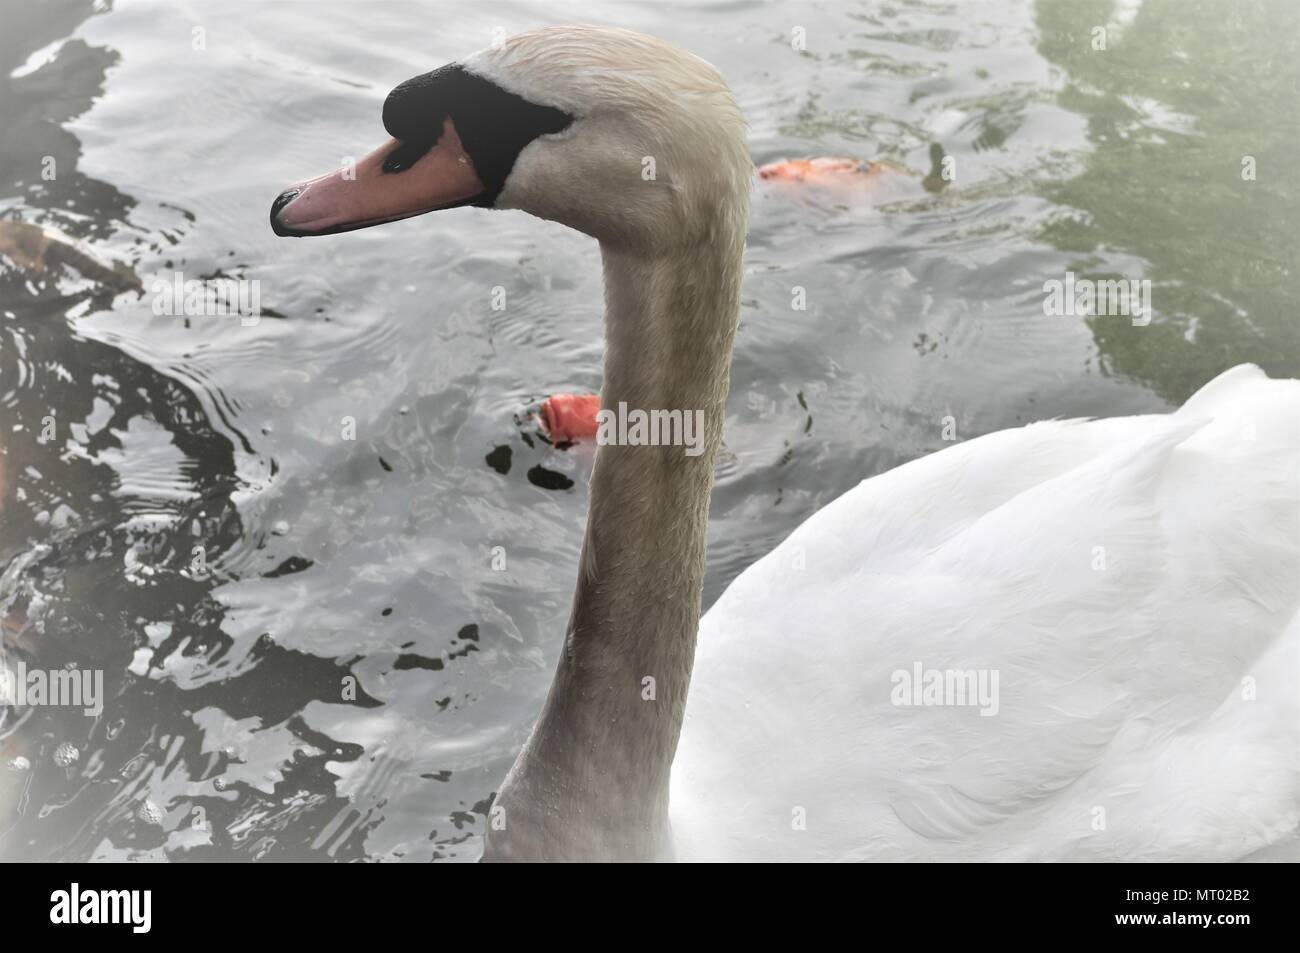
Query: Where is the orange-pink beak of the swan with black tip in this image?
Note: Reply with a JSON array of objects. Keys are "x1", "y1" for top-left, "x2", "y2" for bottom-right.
[{"x1": 270, "y1": 116, "x2": 486, "y2": 235}]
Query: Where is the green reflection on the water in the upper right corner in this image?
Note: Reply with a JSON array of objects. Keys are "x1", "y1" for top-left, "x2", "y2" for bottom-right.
[{"x1": 1036, "y1": 0, "x2": 1300, "y2": 402}]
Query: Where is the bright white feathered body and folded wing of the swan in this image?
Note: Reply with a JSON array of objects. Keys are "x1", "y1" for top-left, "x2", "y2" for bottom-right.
[{"x1": 671, "y1": 367, "x2": 1300, "y2": 859}]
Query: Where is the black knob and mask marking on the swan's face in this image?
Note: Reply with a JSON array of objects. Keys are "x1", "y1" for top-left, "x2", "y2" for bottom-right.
[{"x1": 384, "y1": 64, "x2": 573, "y2": 207}]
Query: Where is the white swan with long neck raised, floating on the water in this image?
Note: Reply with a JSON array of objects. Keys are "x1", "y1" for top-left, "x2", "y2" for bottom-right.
[{"x1": 270, "y1": 26, "x2": 1300, "y2": 861}]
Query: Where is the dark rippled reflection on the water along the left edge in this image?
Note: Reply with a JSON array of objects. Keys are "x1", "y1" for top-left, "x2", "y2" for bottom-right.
[{"x1": 0, "y1": 4, "x2": 376, "y2": 859}]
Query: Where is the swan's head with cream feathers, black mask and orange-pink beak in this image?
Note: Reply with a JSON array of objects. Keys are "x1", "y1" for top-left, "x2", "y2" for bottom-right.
[{"x1": 270, "y1": 26, "x2": 753, "y2": 251}]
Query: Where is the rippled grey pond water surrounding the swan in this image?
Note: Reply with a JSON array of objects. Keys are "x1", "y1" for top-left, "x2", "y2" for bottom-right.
[{"x1": 0, "y1": 0, "x2": 1300, "y2": 861}]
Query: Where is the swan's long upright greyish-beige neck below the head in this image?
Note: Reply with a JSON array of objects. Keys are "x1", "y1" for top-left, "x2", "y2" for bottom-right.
[{"x1": 485, "y1": 216, "x2": 744, "y2": 861}]
